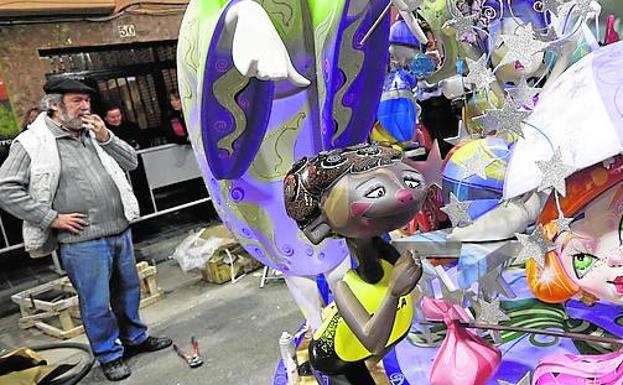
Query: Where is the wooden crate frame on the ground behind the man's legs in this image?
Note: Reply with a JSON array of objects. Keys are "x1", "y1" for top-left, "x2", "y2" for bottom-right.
[{"x1": 11, "y1": 262, "x2": 164, "y2": 339}]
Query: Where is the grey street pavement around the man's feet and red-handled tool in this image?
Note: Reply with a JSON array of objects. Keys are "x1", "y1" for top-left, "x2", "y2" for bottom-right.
[{"x1": 0, "y1": 216, "x2": 303, "y2": 385}]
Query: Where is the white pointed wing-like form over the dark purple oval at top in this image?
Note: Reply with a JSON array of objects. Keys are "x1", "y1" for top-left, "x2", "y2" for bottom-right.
[{"x1": 225, "y1": 0, "x2": 310, "y2": 87}]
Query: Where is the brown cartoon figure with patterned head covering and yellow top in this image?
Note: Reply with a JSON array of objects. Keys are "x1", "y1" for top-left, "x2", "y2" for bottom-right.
[{"x1": 284, "y1": 144, "x2": 426, "y2": 385}]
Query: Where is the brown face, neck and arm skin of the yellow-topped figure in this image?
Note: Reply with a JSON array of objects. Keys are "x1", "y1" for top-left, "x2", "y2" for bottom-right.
[{"x1": 323, "y1": 162, "x2": 426, "y2": 355}]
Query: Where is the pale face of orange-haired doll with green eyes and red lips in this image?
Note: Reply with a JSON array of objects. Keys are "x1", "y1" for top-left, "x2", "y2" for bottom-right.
[{"x1": 561, "y1": 185, "x2": 623, "y2": 304}]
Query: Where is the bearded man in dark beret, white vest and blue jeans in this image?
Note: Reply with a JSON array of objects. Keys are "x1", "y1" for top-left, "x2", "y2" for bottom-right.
[{"x1": 0, "y1": 79, "x2": 171, "y2": 381}]
